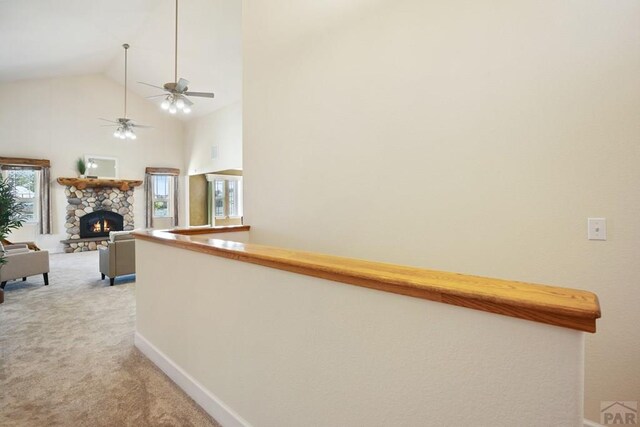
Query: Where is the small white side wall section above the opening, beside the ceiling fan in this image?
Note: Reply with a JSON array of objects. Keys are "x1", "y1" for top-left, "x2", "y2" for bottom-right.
[{"x1": 185, "y1": 101, "x2": 242, "y2": 175}]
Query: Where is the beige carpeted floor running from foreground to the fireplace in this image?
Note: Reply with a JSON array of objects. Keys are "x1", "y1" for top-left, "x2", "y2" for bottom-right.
[{"x1": 0, "y1": 252, "x2": 218, "y2": 427}]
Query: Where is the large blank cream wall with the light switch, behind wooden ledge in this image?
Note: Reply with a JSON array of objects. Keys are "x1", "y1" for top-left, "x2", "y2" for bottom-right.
[{"x1": 243, "y1": 0, "x2": 640, "y2": 419}]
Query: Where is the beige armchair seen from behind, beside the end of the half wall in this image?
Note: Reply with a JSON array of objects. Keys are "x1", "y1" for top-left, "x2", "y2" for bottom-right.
[{"x1": 100, "y1": 233, "x2": 136, "y2": 286}]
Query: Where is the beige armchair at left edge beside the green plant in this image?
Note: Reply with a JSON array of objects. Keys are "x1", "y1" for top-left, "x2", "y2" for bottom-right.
[{"x1": 0, "y1": 245, "x2": 49, "y2": 289}]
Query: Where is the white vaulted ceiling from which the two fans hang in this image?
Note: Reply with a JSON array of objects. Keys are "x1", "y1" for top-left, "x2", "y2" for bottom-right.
[{"x1": 0, "y1": 0, "x2": 242, "y2": 117}]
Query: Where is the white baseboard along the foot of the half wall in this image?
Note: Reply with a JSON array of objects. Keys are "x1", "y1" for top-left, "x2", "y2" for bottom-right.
[{"x1": 134, "y1": 332, "x2": 251, "y2": 427}]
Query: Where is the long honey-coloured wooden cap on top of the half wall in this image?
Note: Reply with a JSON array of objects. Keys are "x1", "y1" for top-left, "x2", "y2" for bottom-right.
[{"x1": 134, "y1": 226, "x2": 600, "y2": 332}]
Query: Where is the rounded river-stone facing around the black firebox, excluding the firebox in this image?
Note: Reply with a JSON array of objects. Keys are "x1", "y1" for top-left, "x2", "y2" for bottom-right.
[{"x1": 64, "y1": 186, "x2": 134, "y2": 252}]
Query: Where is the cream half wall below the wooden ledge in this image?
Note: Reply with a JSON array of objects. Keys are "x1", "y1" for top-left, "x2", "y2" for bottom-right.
[{"x1": 136, "y1": 239, "x2": 584, "y2": 427}]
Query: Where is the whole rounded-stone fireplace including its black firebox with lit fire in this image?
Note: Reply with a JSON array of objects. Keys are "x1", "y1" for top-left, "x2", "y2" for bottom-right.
[{"x1": 62, "y1": 185, "x2": 134, "y2": 252}]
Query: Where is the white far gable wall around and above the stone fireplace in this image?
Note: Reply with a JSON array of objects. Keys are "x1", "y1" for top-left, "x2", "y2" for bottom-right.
[{"x1": 0, "y1": 75, "x2": 185, "y2": 250}]
